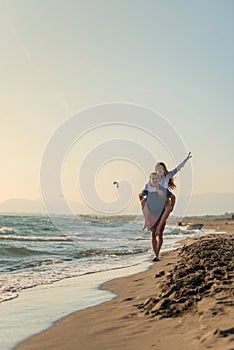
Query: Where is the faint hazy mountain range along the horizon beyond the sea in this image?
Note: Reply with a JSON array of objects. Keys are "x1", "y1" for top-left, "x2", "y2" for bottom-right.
[{"x1": 0, "y1": 193, "x2": 234, "y2": 216}]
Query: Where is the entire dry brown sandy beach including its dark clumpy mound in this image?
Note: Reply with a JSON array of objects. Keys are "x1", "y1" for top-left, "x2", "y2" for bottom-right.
[{"x1": 16, "y1": 220, "x2": 234, "y2": 350}]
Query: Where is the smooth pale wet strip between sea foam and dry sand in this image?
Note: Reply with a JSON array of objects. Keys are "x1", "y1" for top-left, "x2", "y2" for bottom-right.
[{"x1": 0, "y1": 261, "x2": 149, "y2": 350}]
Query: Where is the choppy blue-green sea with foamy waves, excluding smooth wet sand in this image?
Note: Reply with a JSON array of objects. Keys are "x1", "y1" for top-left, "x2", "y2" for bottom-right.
[{"x1": 0, "y1": 216, "x2": 217, "y2": 308}]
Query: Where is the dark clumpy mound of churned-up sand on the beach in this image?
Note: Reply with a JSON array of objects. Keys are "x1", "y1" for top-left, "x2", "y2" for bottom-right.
[{"x1": 138, "y1": 236, "x2": 234, "y2": 318}]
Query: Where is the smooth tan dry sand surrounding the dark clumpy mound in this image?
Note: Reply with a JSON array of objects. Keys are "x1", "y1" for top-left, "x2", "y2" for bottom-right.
[{"x1": 15, "y1": 220, "x2": 233, "y2": 350}]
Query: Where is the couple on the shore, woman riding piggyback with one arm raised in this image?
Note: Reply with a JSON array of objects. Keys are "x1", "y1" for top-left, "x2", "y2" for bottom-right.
[{"x1": 139, "y1": 152, "x2": 192, "y2": 261}]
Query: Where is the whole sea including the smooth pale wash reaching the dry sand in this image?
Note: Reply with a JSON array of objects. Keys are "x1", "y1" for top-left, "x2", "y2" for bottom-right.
[{"x1": 0, "y1": 215, "x2": 218, "y2": 350}]
